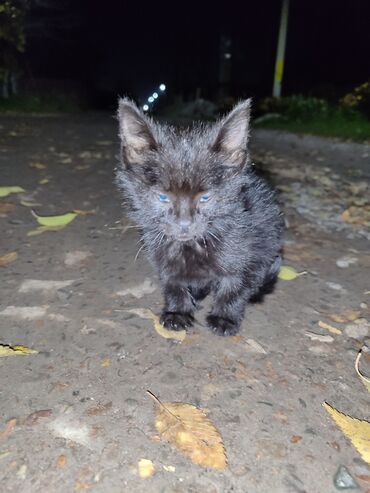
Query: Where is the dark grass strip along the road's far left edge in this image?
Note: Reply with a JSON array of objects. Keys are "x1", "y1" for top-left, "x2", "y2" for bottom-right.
[{"x1": 0, "y1": 94, "x2": 82, "y2": 113}]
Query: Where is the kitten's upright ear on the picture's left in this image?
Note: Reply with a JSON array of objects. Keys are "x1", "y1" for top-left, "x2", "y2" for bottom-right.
[{"x1": 118, "y1": 98, "x2": 158, "y2": 164}]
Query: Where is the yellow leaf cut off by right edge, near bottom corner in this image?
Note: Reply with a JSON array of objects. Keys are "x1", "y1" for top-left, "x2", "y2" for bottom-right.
[{"x1": 323, "y1": 402, "x2": 370, "y2": 464}]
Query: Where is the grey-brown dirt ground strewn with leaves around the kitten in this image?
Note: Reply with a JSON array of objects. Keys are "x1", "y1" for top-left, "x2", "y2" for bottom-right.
[{"x1": 0, "y1": 115, "x2": 370, "y2": 493}]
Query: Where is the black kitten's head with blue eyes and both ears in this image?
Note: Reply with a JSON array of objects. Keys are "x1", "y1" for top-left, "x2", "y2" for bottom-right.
[{"x1": 118, "y1": 100, "x2": 249, "y2": 242}]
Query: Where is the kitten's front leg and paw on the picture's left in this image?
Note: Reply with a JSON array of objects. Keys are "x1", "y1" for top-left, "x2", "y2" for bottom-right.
[{"x1": 160, "y1": 284, "x2": 195, "y2": 330}]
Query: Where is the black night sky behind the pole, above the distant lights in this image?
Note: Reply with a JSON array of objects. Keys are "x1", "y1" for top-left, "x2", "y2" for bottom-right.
[{"x1": 2, "y1": 0, "x2": 370, "y2": 108}]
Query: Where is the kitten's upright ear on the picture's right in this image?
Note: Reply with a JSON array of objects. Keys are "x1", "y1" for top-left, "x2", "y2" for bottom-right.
[{"x1": 213, "y1": 99, "x2": 252, "y2": 166}]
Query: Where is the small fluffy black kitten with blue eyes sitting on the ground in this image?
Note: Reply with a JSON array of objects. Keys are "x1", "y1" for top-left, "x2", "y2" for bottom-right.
[{"x1": 117, "y1": 99, "x2": 282, "y2": 335}]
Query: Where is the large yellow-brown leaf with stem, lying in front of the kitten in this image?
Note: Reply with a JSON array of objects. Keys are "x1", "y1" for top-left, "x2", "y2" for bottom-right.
[{"x1": 147, "y1": 391, "x2": 227, "y2": 469}]
